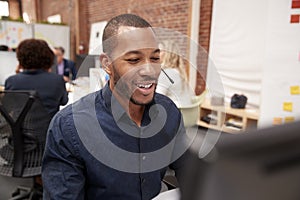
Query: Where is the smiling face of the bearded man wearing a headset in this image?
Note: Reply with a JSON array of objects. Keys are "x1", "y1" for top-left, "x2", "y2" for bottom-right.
[{"x1": 106, "y1": 27, "x2": 161, "y2": 105}]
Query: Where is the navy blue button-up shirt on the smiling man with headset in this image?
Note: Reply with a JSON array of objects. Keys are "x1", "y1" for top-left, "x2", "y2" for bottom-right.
[{"x1": 42, "y1": 82, "x2": 187, "y2": 200}]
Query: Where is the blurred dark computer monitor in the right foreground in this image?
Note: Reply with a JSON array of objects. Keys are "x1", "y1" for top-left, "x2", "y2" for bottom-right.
[{"x1": 181, "y1": 122, "x2": 300, "y2": 200}]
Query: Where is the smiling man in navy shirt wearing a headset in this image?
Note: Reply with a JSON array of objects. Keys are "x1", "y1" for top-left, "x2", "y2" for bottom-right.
[{"x1": 42, "y1": 14, "x2": 187, "y2": 200}]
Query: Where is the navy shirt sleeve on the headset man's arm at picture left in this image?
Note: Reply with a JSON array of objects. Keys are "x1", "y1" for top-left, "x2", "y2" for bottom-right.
[{"x1": 42, "y1": 114, "x2": 85, "y2": 200}]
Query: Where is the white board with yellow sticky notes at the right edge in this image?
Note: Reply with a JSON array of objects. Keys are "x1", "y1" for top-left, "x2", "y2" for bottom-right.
[{"x1": 259, "y1": 0, "x2": 300, "y2": 126}]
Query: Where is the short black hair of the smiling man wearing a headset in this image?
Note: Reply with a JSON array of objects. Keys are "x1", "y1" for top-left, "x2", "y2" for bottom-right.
[{"x1": 102, "y1": 14, "x2": 152, "y2": 54}]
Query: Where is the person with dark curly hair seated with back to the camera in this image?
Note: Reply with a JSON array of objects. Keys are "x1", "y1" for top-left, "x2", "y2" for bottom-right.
[{"x1": 5, "y1": 39, "x2": 68, "y2": 117}]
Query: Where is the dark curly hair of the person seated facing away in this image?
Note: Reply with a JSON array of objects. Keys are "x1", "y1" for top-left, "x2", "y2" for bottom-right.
[{"x1": 16, "y1": 39, "x2": 54, "y2": 70}]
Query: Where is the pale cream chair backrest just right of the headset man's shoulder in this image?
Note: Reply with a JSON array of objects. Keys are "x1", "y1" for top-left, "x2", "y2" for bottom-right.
[{"x1": 179, "y1": 91, "x2": 206, "y2": 127}]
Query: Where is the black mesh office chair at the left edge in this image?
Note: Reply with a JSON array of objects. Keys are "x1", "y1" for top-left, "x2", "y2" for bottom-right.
[{"x1": 0, "y1": 91, "x2": 51, "y2": 199}]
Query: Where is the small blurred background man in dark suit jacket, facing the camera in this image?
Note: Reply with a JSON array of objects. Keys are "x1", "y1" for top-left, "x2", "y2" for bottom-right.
[{"x1": 52, "y1": 47, "x2": 77, "y2": 82}]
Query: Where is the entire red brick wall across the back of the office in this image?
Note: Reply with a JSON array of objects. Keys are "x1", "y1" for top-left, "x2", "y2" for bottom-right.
[{"x1": 5, "y1": 0, "x2": 213, "y2": 94}]
